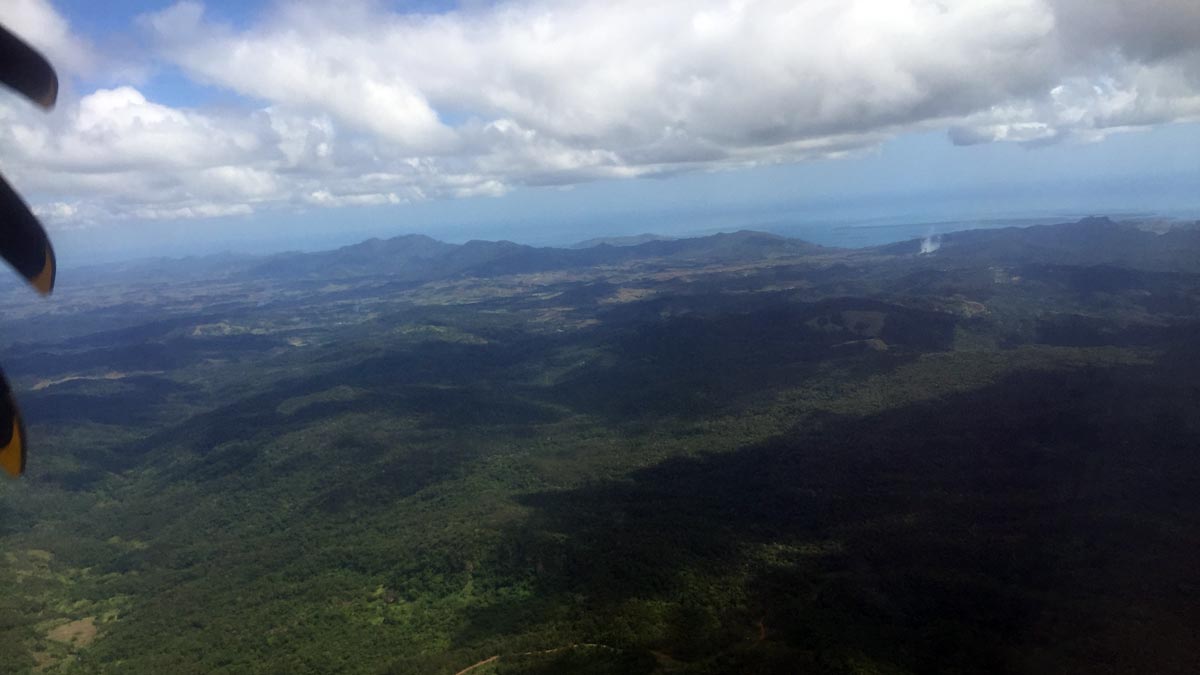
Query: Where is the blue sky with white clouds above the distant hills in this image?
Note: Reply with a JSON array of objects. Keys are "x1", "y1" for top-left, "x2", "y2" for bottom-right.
[{"x1": 0, "y1": 0, "x2": 1200, "y2": 264}]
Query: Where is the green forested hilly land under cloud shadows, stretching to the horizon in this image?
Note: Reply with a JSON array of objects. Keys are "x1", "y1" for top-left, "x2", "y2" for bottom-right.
[{"x1": 0, "y1": 219, "x2": 1200, "y2": 675}]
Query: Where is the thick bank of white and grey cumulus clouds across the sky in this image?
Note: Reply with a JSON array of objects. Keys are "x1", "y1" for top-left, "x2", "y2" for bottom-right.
[{"x1": 0, "y1": 0, "x2": 1200, "y2": 225}]
